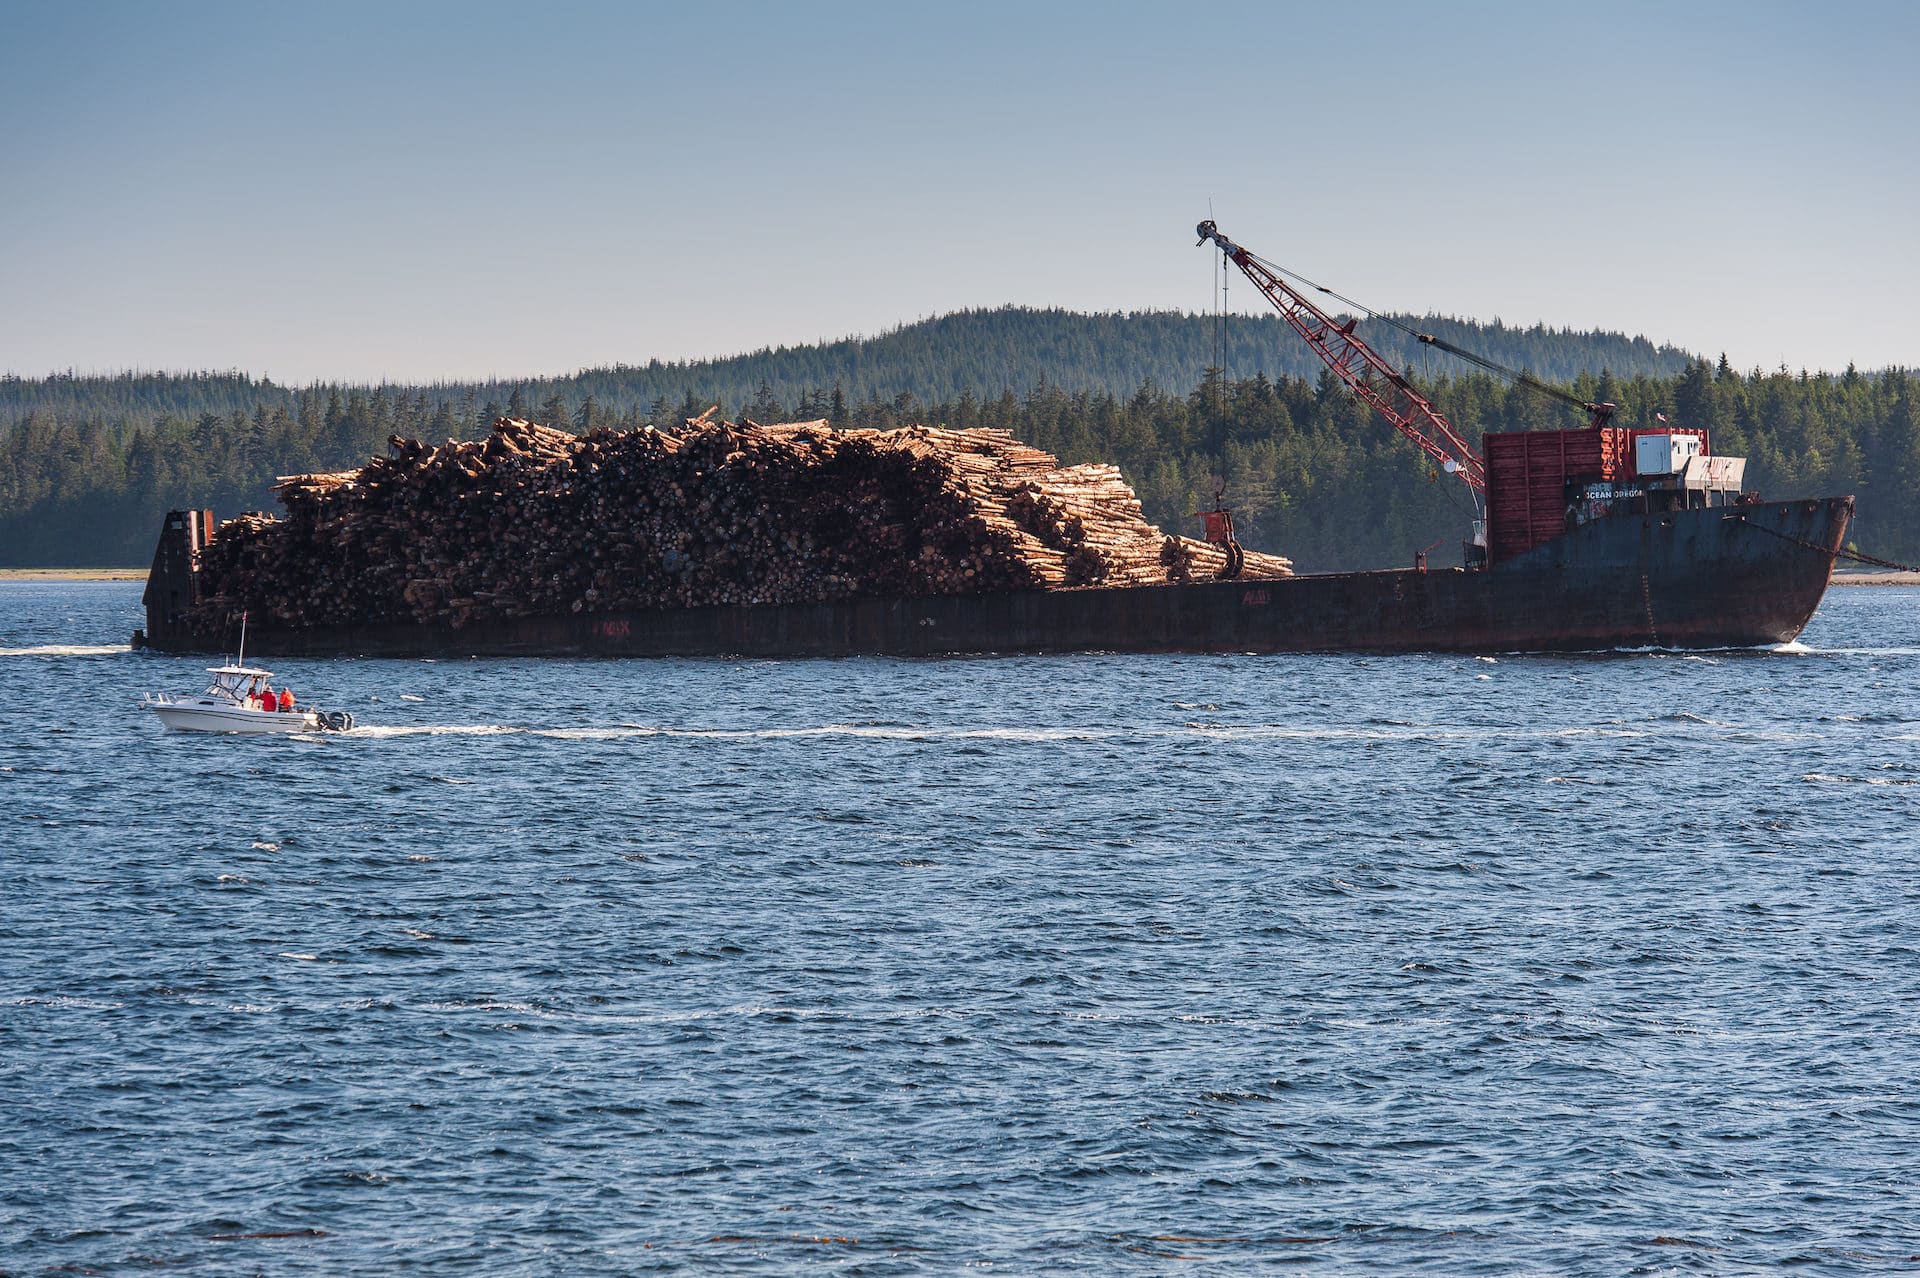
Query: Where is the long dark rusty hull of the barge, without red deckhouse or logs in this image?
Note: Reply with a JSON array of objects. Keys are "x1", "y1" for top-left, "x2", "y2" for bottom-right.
[{"x1": 136, "y1": 497, "x2": 1853, "y2": 656}]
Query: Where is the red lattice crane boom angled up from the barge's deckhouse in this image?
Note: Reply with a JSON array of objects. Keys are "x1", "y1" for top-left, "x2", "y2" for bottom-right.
[{"x1": 1198, "y1": 221, "x2": 1486, "y2": 493}]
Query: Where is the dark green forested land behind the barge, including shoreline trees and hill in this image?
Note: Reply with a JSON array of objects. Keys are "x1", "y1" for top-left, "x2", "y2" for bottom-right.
[{"x1": 0, "y1": 311, "x2": 1920, "y2": 570}]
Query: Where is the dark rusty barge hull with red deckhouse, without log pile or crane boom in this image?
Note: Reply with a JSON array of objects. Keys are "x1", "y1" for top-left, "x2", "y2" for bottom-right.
[{"x1": 136, "y1": 426, "x2": 1853, "y2": 658}]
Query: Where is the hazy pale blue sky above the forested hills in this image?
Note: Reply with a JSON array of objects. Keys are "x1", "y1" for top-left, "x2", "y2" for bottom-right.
[{"x1": 0, "y1": 0, "x2": 1920, "y2": 382}]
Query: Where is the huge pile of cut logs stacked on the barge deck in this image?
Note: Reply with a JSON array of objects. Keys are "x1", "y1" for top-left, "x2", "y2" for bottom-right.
[{"x1": 194, "y1": 416, "x2": 1292, "y2": 631}]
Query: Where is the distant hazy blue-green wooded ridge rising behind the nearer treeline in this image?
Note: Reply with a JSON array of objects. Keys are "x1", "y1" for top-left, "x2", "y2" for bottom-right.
[{"x1": 0, "y1": 307, "x2": 1688, "y2": 424}]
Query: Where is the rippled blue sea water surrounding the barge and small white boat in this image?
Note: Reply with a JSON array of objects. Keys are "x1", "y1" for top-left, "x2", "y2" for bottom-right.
[{"x1": 0, "y1": 583, "x2": 1920, "y2": 1274}]
